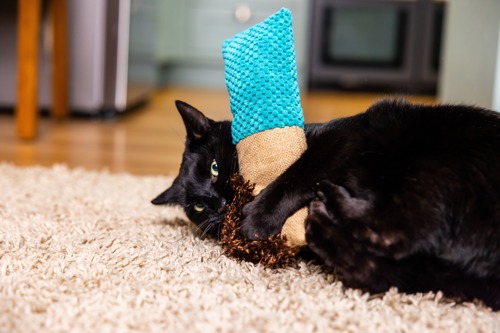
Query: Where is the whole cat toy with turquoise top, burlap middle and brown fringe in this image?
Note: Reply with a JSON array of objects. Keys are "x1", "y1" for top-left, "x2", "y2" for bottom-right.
[{"x1": 221, "y1": 8, "x2": 307, "y2": 267}]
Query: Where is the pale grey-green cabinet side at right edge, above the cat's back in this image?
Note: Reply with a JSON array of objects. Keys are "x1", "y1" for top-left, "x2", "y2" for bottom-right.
[{"x1": 439, "y1": 0, "x2": 500, "y2": 111}]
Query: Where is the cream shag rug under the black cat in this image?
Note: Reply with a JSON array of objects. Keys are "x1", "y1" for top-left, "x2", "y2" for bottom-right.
[{"x1": 0, "y1": 164, "x2": 500, "y2": 333}]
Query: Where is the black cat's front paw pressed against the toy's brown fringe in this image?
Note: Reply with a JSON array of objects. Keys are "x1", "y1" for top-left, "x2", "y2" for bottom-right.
[{"x1": 240, "y1": 200, "x2": 281, "y2": 241}]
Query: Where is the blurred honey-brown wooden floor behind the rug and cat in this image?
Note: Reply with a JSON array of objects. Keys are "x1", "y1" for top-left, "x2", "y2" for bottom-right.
[{"x1": 0, "y1": 87, "x2": 435, "y2": 175}]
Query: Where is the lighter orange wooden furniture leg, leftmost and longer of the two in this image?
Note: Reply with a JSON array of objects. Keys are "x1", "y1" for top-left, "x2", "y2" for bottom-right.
[{"x1": 16, "y1": 0, "x2": 41, "y2": 140}]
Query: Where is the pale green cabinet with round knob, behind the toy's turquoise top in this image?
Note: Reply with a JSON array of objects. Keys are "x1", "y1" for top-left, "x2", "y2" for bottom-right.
[{"x1": 155, "y1": 0, "x2": 310, "y2": 87}]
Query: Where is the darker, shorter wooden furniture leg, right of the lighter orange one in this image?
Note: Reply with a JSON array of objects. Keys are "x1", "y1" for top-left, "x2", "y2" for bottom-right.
[{"x1": 50, "y1": 0, "x2": 68, "y2": 119}]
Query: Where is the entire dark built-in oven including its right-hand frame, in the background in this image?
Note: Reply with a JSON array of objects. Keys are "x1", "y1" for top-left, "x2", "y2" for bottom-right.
[{"x1": 309, "y1": 0, "x2": 446, "y2": 93}]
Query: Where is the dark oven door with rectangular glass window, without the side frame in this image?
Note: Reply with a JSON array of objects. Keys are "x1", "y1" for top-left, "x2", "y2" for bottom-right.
[{"x1": 310, "y1": 0, "x2": 418, "y2": 88}]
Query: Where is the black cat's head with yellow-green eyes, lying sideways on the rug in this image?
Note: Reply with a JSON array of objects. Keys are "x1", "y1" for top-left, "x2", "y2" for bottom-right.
[{"x1": 152, "y1": 101, "x2": 238, "y2": 237}]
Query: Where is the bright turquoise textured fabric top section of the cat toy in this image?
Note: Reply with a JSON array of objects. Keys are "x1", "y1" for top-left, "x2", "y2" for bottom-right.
[{"x1": 222, "y1": 8, "x2": 304, "y2": 144}]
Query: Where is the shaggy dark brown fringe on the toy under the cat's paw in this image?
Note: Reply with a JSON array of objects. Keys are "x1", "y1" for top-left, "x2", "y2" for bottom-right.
[{"x1": 221, "y1": 173, "x2": 300, "y2": 268}]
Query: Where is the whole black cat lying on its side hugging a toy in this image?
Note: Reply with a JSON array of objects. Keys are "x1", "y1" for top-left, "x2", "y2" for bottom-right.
[{"x1": 153, "y1": 101, "x2": 500, "y2": 309}]
